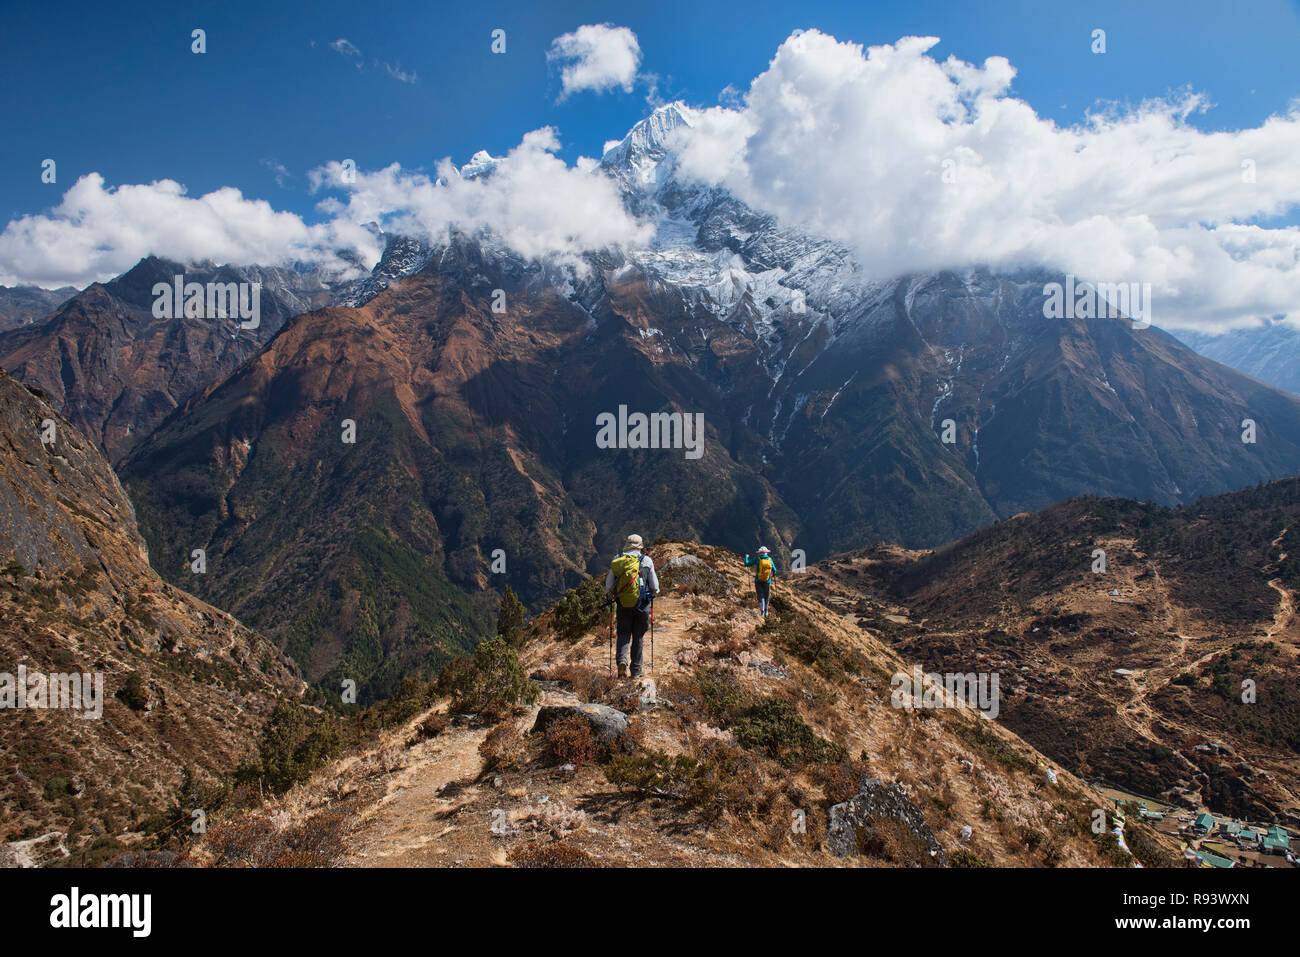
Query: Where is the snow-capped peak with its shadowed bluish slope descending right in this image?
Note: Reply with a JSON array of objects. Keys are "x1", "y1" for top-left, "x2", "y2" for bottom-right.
[{"x1": 592, "y1": 104, "x2": 1300, "y2": 546}]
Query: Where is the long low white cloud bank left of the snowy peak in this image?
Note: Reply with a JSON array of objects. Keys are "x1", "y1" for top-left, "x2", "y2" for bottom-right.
[{"x1": 0, "y1": 127, "x2": 653, "y2": 287}]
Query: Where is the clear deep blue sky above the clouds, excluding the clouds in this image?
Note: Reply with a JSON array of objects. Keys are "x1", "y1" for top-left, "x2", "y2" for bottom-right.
[{"x1": 0, "y1": 0, "x2": 1300, "y2": 221}]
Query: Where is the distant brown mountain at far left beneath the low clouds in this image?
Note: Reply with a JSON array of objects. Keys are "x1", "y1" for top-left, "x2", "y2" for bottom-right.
[{"x1": 0, "y1": 257, "x2": 328, "y2": 463}]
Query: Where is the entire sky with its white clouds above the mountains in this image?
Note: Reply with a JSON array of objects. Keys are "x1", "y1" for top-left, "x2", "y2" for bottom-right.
[{"x1": 0, "y1": 0, "x2": 1300, "y2": 330}]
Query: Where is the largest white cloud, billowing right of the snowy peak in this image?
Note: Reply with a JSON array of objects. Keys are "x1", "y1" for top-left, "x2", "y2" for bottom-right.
[{"x1": 680, "y1": 30, "x2": 1300, "y2": 328}]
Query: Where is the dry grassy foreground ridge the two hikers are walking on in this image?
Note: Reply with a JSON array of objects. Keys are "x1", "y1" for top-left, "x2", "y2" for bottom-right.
[{"x1": 181, "y1": 542, "x2": 1178, "y2": 867}]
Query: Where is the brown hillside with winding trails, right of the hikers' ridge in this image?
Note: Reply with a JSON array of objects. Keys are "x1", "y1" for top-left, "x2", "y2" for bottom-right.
[{"x1": 798, "y1": 479, "x2": 1300, "y2": 823}]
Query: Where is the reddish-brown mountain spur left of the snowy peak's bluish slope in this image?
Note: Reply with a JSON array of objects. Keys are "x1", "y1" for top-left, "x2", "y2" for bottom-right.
[{"x1": 126, "y1": 243, "x2": 788, "y2": 693}]
